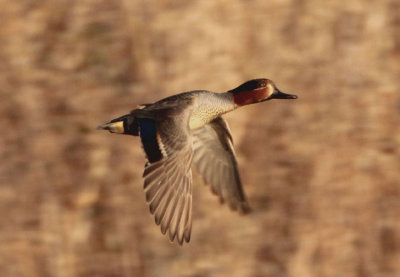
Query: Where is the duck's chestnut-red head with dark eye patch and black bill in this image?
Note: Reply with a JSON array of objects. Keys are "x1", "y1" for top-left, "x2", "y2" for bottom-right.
[{"x1": 229, "y1": 79, "x2": 297, "y2": 106}]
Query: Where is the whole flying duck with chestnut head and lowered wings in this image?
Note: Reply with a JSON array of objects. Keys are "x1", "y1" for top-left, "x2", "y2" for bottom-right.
[{"x1": 97, "y1": 78, "x2": 297, "y2": 245}]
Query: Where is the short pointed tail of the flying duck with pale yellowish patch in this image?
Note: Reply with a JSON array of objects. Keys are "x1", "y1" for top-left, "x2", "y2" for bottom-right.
[{"x1": 96, "y1": 114, "x2": 139, "y2": 136}]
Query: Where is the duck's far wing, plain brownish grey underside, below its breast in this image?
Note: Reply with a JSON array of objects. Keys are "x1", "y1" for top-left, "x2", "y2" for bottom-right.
[{"x1": 192, "y1": 117, "x2": 250, "y2": 212}]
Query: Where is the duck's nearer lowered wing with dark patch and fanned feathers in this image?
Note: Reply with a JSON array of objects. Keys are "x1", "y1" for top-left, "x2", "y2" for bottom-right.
[{"x1": 139, "y1": 117, "x2": 193, "y2": 244}]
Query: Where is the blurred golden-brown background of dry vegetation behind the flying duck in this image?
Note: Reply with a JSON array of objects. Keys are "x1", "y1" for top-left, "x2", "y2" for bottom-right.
[{"x1": 0, "y1": 0, "x2": 400, "y2": 277}]
